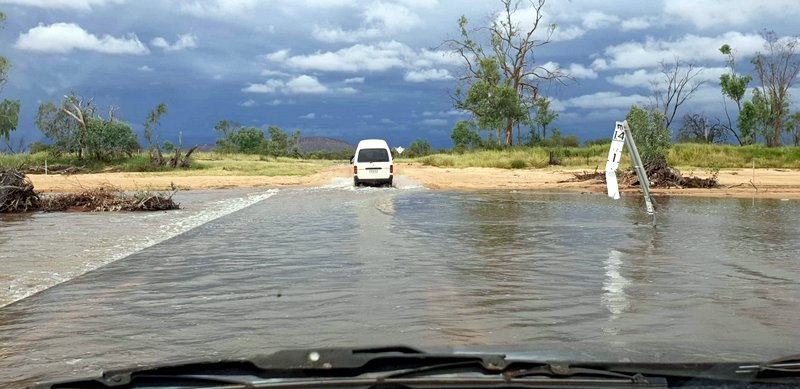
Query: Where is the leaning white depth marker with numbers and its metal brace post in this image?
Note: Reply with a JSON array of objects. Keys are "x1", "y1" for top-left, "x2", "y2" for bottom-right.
[{"x1": 606, "y1": 120, "x2": 656, "y2": 227}]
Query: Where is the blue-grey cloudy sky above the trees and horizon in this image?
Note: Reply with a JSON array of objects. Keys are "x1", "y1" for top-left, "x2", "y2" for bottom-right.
[{"x1": 0, "y1": 0, "x2": 800, "y2": 147}]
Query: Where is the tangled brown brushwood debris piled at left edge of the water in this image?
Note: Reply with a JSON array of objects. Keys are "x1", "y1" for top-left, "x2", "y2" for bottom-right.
[{"x1": 0, "y1": 169, "x2": 180, "y2": 213}]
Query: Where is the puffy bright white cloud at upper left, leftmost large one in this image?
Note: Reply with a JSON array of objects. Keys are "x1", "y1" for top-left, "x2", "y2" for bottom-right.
[{"x1": 14, "y1": 23, "x2": 150, "y2": 55}]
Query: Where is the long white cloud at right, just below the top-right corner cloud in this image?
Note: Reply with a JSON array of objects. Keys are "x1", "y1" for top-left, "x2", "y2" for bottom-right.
[{"x1": 592, "y1": 31, "x2": 764, "y2": 70}]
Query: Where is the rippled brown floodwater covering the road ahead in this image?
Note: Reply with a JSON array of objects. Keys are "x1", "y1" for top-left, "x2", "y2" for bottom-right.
[{"x1": 0, "y1": 180, "x2": 800, "y2": 385}]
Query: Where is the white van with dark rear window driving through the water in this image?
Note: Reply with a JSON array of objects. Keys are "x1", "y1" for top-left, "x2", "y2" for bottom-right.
[{"x1": 350, "y1": 139, "x2": 394, "y2": 186}]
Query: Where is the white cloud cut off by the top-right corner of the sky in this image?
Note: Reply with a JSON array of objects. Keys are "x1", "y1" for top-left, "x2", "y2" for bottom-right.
[{"x1": 664, "y1": 0, "x2": 800, "y2": 29}]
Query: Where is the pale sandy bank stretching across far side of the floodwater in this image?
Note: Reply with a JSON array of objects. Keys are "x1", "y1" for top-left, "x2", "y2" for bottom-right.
[{"x1": 29, "y1": 163, "x2": 800, "y2": 199}]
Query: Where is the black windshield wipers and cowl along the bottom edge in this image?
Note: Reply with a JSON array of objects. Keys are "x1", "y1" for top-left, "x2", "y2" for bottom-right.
[{"x1": 34, "y1": 347, "x2": 800, "y2": 389}]
